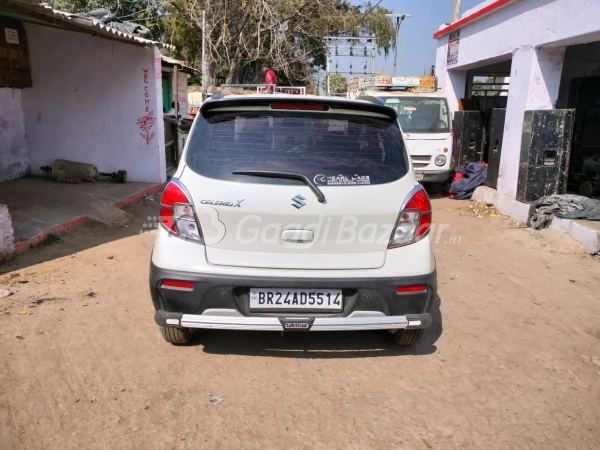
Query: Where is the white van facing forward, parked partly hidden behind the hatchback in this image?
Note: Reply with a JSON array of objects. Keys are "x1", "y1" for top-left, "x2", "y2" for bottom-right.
[{"x1": 363, "y1": 90, "x2": 453, "y2": 192}]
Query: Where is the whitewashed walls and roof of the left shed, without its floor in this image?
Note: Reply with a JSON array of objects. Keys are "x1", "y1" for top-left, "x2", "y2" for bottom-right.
[{"x1": 0, "y1": 0, "x2": 173, "y2": 183}]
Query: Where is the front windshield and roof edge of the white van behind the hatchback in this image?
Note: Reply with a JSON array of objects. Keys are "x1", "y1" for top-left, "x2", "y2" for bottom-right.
[{"x1": 383, "y1": 96, "x2": 450, "y2": 133}]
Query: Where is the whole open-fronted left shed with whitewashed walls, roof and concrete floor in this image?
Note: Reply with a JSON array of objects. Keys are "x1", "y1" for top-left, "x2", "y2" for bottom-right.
[{"x1": 0, "y1": 0, "x2": 176, "y2": 261}]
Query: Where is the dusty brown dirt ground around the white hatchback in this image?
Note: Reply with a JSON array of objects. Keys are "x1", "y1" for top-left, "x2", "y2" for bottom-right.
[{"x1": 0, "y1": 199, "x2": 600, "y2": 449}]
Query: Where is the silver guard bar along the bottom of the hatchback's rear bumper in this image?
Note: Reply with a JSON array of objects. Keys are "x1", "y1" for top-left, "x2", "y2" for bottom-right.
[{"x1": 154, "y1": 310, "x2": 431, "y2": 331}]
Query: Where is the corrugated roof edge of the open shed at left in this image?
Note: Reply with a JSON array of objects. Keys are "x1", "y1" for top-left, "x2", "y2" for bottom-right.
[{"x1": 0, "y1": 0, "x2": 175, "y2": 50}]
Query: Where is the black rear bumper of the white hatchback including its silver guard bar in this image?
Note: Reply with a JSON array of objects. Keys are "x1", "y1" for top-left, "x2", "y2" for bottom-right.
[{"x1": 150, "y1": 264, "x2": 437, "y2": 331}]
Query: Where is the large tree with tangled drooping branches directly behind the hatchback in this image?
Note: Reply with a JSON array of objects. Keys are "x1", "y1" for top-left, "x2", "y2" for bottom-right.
[{"x1": 169, "y1": 0, "x2": 395, "y2": 84}]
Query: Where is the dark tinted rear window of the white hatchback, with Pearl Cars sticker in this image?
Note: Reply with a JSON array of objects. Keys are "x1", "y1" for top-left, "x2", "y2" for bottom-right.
[{"x1": 187, "y1": 111, "x2": 407, "y2": 186}]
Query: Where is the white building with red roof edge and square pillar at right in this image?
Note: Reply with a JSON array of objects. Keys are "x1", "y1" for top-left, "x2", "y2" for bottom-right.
[{"x1": 434, "y1": 0, "x2": 600, "y2": 198}]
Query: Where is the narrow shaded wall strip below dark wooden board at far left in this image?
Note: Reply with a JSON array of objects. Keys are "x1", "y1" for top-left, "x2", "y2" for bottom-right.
[{"x1": 0, "y1": 88, "x2": 29, "y2": 182}]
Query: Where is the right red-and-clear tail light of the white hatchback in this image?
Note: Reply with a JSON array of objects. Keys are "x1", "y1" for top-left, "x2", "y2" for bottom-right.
[{"x1": 388, "y1": 185, "x2": 431, "y2": 248}]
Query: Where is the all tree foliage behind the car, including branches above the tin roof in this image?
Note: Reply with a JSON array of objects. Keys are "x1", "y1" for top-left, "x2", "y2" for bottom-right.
[{"x1": 47, "y1": 0, "x2": 395, "y2": 87}]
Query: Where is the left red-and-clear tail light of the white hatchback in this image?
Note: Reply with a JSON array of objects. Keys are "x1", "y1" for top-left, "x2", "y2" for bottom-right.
[{"x1": 160, "y1": 180, "x2": 204, "y2": 244}]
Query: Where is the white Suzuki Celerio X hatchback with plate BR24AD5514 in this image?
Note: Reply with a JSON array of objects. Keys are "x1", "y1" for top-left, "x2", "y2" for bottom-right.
[{"x1": 150, "y1": 95, "x2": 437, "y2": 345}]
